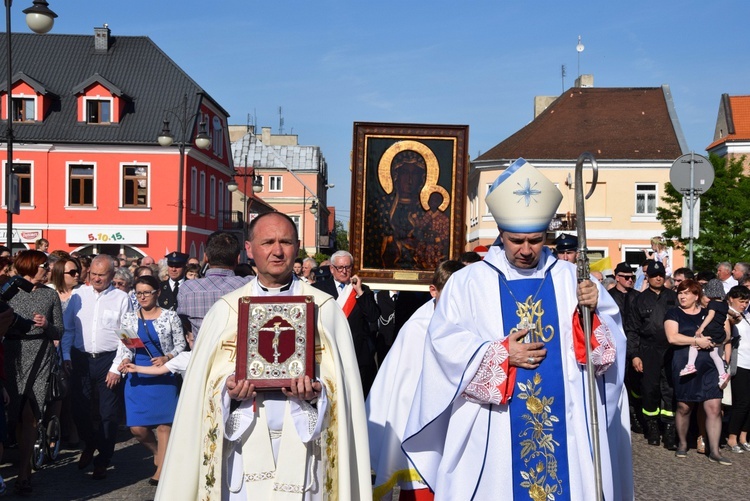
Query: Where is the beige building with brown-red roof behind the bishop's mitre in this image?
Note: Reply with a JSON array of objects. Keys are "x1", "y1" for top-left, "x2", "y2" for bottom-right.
[{"x1": 467, "y1": 81, "x2": 688, "y2": 269}]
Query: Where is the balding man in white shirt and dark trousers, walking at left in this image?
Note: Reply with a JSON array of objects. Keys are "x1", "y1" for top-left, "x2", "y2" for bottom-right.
[{"x1": 62, "y1": 255, "x2": 131, "y2": 480}]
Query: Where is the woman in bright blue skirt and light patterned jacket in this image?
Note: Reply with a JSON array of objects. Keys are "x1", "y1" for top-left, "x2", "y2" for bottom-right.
[{"x1": 120, "y1": 275, "x2": 185, "y2": 485}]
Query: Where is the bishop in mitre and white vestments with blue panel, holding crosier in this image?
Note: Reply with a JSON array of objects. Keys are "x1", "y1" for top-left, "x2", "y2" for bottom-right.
[{"x1": 402, "y1": 159, "x2": 633, "y2": 501}]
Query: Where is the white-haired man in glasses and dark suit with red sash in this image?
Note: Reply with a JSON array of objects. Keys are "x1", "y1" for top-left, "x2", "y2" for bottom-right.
[{"x1": 313, "y1": 251, "x2": 380, "y2": 398}]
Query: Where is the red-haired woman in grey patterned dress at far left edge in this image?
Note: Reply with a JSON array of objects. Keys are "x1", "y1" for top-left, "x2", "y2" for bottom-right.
[{"x1": 3, "y1": 250, "x2": 63, "y2": 495}]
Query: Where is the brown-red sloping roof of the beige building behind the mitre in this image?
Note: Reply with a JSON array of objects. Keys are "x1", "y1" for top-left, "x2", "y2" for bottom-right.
[{"x1": 476, "y1": 87, "x2": 683, "y2": 161}]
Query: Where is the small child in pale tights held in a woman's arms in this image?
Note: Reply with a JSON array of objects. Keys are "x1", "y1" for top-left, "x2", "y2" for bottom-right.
[{"x1": 680, "y1": 278, "x2": 731, "y2": 390}]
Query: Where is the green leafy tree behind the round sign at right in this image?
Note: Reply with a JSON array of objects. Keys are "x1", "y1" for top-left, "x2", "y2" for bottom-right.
[{"x1": 656, "y1": 155, "x2": 750, "y2": 270}]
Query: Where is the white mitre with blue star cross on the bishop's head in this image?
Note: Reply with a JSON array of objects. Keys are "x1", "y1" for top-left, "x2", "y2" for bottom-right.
[{"x1": 486, "y1": 158, "x2": 562, "y2": 233}]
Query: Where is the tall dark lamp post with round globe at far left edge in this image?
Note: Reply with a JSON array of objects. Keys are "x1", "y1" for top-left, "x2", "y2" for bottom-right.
[{"x1": 5, "y1": 0, "x2": 57, "y2": 249}]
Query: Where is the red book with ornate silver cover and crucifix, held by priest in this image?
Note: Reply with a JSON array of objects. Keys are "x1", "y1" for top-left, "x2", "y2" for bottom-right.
[{"x1": 235, "y1": 296, "x2": 315, "y2": 390}]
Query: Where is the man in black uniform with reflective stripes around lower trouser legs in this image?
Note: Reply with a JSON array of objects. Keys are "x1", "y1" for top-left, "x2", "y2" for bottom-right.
[{"x1": 625, "y1": 261, "x2": 677, "y2": 450}]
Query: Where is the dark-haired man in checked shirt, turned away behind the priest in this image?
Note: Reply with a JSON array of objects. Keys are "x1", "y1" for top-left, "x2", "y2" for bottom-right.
[{"x1": 177, "y1": 231, "x2": 251, "y2": 339}]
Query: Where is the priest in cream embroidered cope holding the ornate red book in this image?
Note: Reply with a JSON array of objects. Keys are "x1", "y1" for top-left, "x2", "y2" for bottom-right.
[{"x1": 156, "y1": 212, "x2": 371, "y2": 501}]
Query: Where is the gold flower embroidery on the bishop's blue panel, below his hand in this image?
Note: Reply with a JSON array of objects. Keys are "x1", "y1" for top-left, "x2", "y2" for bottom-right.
[{"x1": 517, "y1": 372, "x2": 562, "y2": 501}]
